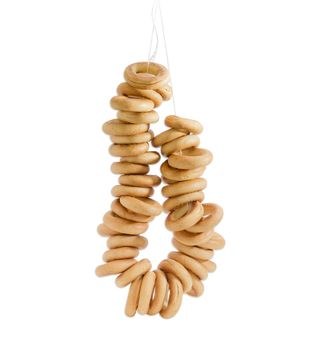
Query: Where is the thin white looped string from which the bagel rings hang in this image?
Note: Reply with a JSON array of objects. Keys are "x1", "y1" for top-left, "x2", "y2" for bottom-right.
[{"x1": 147, "y1": 0, "x2": 176, "y2": 115}]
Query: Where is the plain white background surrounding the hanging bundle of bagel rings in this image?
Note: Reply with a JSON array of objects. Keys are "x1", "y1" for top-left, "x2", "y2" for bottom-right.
[{"x1": 0, "y1": 0, "x2": 313, "y2": 350}]
